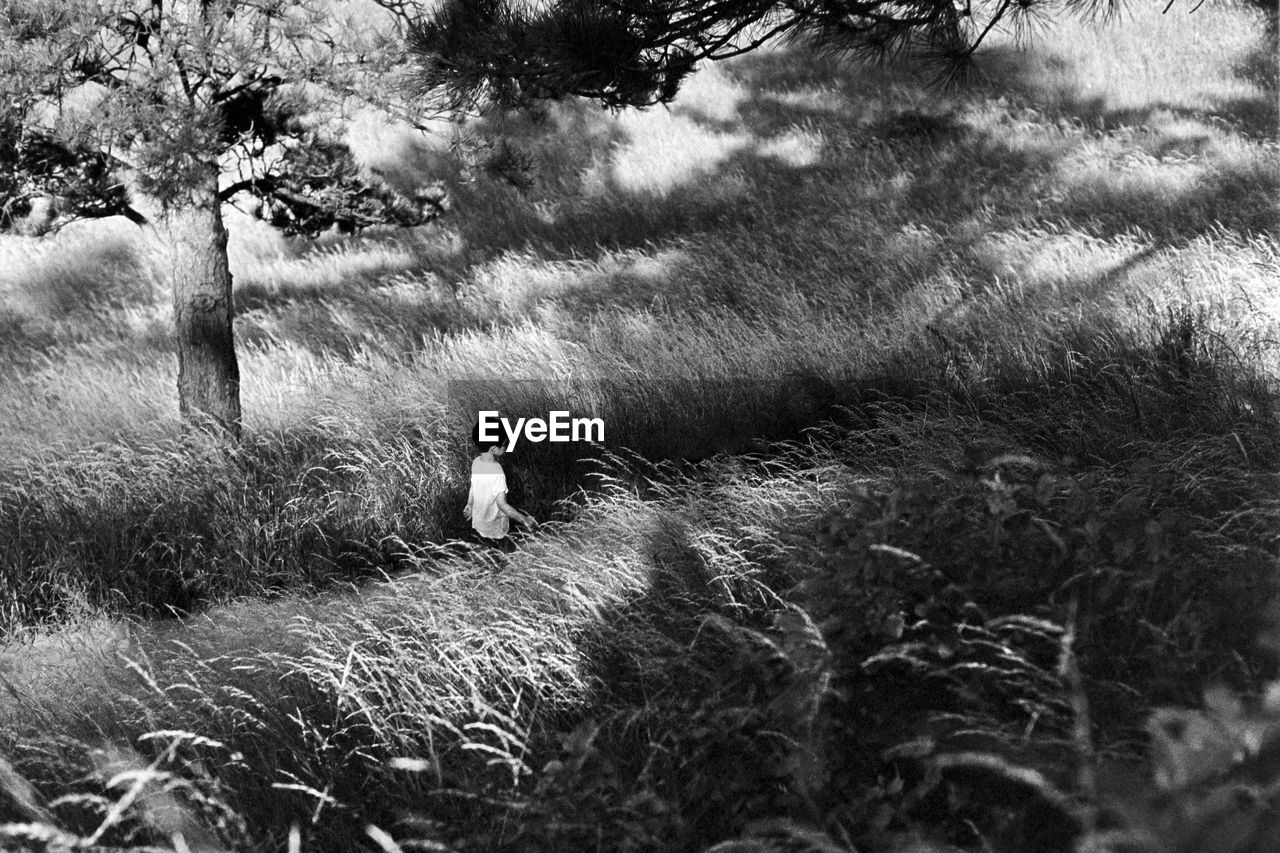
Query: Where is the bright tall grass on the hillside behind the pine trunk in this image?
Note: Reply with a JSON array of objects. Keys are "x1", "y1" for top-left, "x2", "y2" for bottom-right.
[{"x1": 0, "y1": 8, "x2": 1277, "y2": 460}]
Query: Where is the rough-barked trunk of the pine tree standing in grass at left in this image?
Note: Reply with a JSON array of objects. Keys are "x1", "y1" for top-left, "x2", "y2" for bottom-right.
[{"x1": 154, "y1": 169, "x2": 241, "y2": 441}]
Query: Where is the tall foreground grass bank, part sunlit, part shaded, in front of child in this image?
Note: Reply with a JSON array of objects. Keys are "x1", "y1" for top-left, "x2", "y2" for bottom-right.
[{"x1": 3, "y1": 379, "x2": 1280, "y2": 849}]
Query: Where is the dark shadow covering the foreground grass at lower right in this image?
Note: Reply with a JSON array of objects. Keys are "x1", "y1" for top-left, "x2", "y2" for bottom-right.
[{"x1": 414, "y1": 343, "x2": 1280, "y2": 850}]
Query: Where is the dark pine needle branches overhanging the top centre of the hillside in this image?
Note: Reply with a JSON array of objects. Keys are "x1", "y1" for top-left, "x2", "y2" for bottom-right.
[{"x1": 410, "y1": 0, "x2": 1110, "y2": 109}]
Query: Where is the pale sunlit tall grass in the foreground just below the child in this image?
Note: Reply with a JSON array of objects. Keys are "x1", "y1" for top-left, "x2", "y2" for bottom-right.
[{"x1": 4, "y1": 461, "x2": 829, "y2": 849}]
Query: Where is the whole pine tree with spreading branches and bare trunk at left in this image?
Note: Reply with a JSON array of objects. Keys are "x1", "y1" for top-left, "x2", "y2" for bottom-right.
[{"x1": 0, "y1": 0, "x2": 442, "y2": 438}]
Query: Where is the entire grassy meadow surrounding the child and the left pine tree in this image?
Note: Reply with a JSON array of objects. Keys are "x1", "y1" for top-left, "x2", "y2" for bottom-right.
[{"x1": 0, "y1": 0, "x2": 1280, "y2": 853}]
